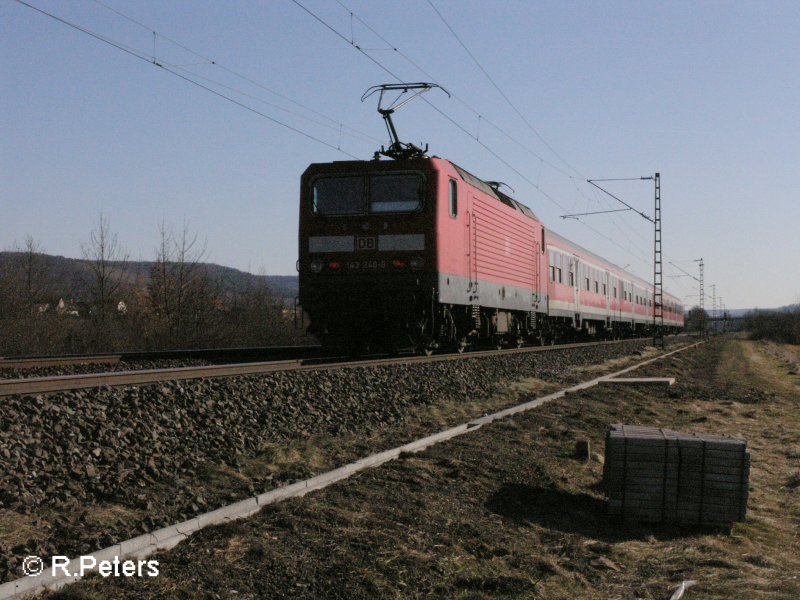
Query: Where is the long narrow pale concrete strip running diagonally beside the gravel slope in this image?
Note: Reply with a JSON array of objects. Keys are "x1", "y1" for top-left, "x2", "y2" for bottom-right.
[{"x1": 0, "y1": 342, "x2": 703, "y2": 600}]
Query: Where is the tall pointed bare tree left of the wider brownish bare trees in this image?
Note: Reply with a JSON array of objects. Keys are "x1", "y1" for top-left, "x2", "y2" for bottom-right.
[{"x1": 81, "y1": 212, "x2": 128, "y2": 324}]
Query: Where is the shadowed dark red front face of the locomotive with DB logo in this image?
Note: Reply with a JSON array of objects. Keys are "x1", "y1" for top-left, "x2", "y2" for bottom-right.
[{"x1": 299, "y1": 158, "x2": 438, "y2": 349}]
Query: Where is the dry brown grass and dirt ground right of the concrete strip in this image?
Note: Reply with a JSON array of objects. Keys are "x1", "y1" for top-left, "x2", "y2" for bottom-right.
[{"x1": 43, "y1": 338, "x2": 800, "y2": 599}]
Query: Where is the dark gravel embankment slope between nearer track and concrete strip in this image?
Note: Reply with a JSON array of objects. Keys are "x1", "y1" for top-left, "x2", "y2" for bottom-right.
[{"x1": 0, "y1": 342, "x2": 668, "y2": 581}]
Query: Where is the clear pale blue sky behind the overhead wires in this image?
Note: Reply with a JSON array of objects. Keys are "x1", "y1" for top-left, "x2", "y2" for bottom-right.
[{"x1": 0, "y1": 0, "x2": 800, "y2": 308}]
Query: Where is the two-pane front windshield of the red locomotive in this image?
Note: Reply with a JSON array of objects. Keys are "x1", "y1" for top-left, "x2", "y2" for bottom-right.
[{"x1": 311, "y1": 173, "x2": 424, "y2": 216}]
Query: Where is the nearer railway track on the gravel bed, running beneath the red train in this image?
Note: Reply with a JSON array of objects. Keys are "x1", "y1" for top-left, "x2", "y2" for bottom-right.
[{"x1": 0, "y1": 339, "x2": 664, "y2": 397}]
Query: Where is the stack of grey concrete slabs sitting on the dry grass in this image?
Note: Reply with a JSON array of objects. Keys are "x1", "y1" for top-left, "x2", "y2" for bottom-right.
[{"x1": 603, "y1": 425, "x2": 750, "y2": 526}]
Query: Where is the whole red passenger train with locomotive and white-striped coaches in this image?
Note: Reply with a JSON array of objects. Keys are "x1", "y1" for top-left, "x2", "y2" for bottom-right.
[{"x1": 298, "y1": 86, "x2": 684, "y2": 353}]
